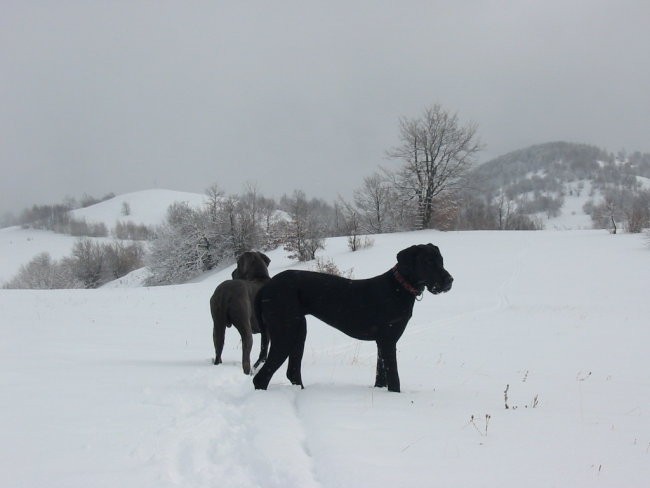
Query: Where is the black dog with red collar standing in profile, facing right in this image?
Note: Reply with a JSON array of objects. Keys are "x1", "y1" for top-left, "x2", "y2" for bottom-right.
[{"x1": 253, "y1": 244, "x2": 453, "y2": 391}]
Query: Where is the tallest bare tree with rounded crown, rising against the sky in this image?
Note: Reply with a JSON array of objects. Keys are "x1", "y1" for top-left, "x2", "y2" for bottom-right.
[{"x1": 387, "y1": 104, "x2": 482, "y2": 228}]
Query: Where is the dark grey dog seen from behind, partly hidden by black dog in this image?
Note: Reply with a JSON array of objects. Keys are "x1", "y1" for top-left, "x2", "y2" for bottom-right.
[{"x1": 210, "y1": 251, "x2": 271, "y2": 374}]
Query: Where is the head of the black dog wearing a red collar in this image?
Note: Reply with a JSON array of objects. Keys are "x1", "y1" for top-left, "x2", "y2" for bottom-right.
[{"x1": 397, "y1": 244, "x2": 454, "y2": 294}]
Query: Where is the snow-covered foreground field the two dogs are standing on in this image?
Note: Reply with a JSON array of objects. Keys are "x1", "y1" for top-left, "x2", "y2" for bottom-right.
[{"x1": 0, "y1": 231, "x2": 650, "y2": 488}]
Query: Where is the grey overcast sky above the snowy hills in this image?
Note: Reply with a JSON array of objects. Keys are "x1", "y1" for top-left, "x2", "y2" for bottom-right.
[{"x1": 0, "y1": 0, "x2": 650, "y2": 213}]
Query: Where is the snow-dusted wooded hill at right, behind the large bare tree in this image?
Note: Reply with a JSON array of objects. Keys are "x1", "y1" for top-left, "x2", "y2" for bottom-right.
[{"x1": 469, "y1": 142, "x2": 650, "y2": 229}]
